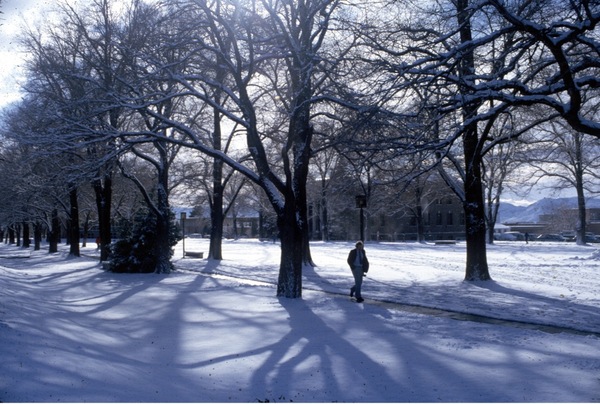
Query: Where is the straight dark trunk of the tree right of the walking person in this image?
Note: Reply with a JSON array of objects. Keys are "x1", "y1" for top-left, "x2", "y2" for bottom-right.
[{"x1": 456, "y1": 0, "x2": 491, "y2": 281}]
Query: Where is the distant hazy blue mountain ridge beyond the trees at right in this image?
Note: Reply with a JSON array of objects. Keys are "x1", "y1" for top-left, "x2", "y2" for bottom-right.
[{"x1": 497, "y1": 197, "x2": 600, "y2": 223}]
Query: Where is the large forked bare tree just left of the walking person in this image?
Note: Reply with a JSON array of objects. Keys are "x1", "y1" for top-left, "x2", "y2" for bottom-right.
[{"x1": 125, "y1": 0, "x2": 346, "y2": 297}]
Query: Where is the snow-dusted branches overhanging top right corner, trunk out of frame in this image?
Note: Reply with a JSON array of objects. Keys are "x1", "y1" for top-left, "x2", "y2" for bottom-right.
[{"x1": 486, "y1": 0, "x2": 600, "y2": 137}]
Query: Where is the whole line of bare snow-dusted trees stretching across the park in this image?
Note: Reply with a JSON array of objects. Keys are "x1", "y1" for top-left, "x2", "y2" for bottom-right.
[{"x1": 0, "y1": 0, "x2": 600, "y2": 298}]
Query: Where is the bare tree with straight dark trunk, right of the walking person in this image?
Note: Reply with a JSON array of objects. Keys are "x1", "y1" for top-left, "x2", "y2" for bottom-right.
[{"x1": 352, "y1": 0, "x2": 495, "y2": 280}]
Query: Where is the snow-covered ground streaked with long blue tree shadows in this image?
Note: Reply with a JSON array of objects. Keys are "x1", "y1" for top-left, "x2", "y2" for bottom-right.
[{"x1": 0, "y1": 239, "x2": 600, "y2": 402}]
